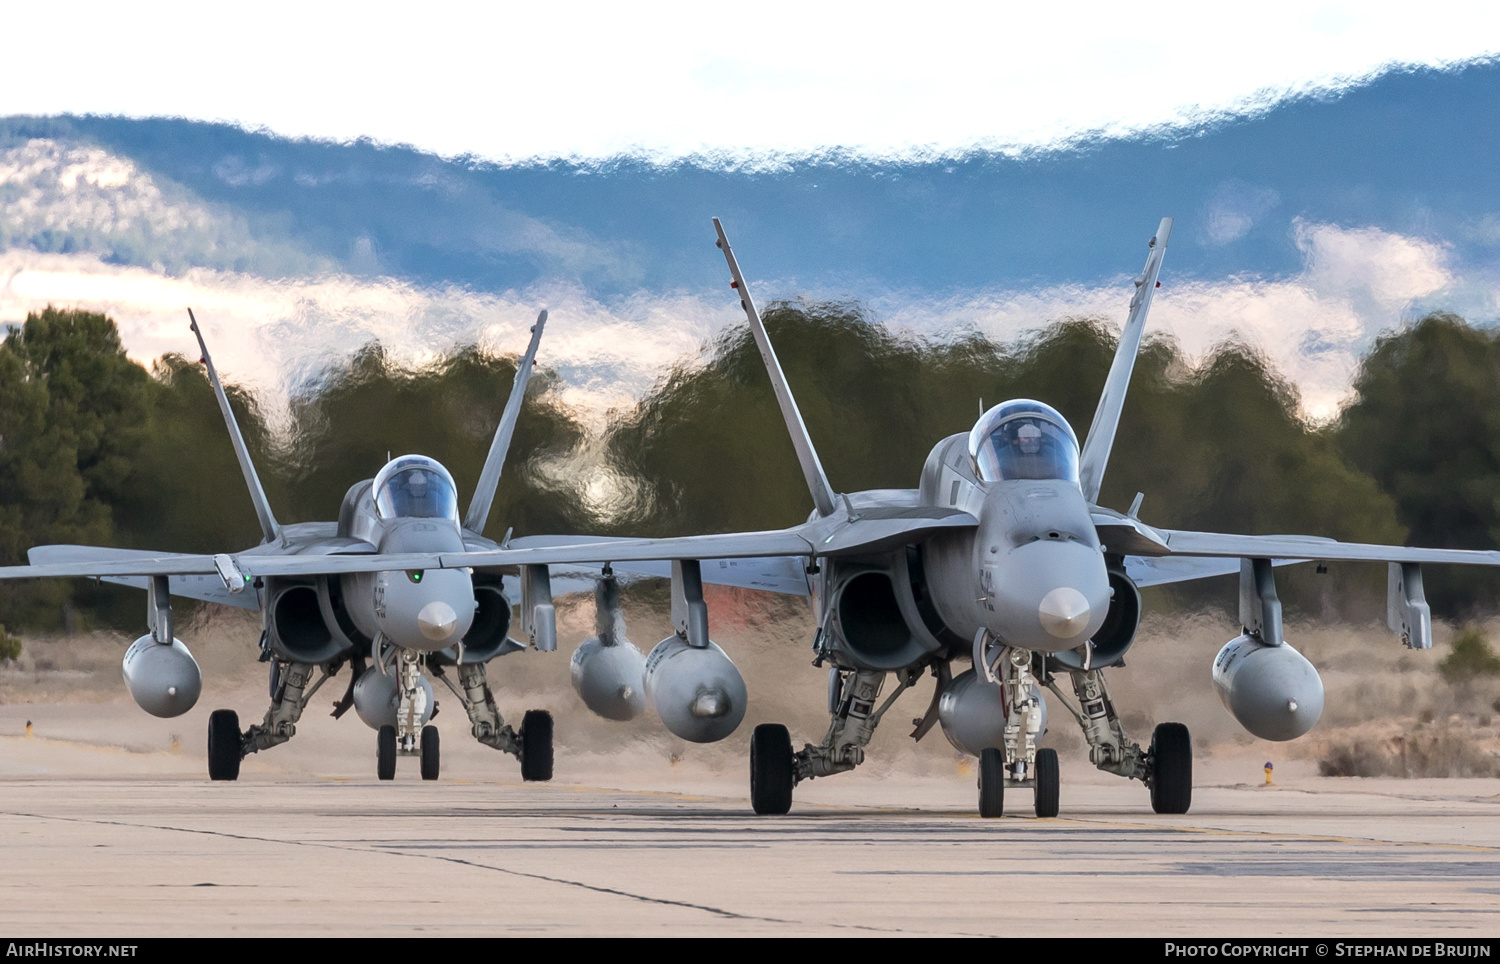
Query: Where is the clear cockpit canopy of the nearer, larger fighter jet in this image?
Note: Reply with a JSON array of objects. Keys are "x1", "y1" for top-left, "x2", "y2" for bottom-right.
[{"x1": 969, "y1": 399, "x2": 1079, "y2": 484}]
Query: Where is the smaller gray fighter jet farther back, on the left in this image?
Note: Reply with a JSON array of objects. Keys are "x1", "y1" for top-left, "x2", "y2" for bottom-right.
[{"x1": 0, "y1": 310, "x2": 557, "y2": 780}]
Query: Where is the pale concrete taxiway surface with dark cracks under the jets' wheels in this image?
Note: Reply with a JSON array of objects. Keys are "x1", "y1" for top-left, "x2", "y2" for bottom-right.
[{"x1": 0, "y1": 738, "x2": 1500, "y2": 939}]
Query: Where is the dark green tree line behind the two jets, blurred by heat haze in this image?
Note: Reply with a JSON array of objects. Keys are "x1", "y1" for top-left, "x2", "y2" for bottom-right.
[{"x1": 0, "y1": 303, "x2": 1500, "y2": 628}]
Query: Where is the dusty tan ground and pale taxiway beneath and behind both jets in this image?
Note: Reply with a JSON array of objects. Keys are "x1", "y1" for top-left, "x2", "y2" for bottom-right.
[{"x1": 0, "y1": 595, "x2": 1500, "y2": 937}]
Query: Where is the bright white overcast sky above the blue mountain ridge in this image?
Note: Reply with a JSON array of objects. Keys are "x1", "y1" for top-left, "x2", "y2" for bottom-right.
[{"x1": 0, "y1": 0, "x2": 1500, "y2": 159}]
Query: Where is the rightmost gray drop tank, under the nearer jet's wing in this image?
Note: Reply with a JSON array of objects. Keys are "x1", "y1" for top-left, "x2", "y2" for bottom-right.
[{"x1": 1214, "y1": 633, "x2": 1323, "y2": 741}]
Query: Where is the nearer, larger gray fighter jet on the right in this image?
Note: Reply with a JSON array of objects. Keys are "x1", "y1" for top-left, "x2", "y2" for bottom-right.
[{"x1": 452, "y1": 217, "x2": 1500, "y2": 817}]
